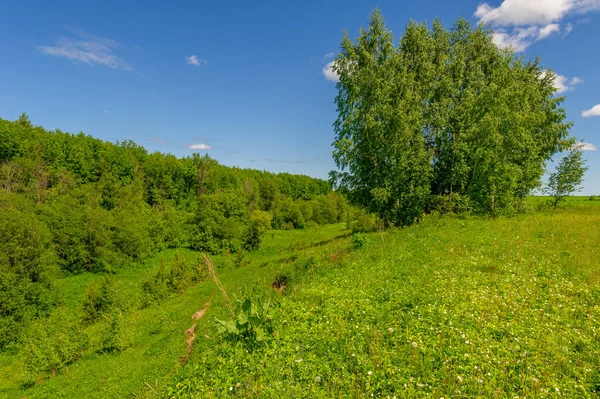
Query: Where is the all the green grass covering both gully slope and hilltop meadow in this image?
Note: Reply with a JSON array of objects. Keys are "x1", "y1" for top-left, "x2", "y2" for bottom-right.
[{"x1": 0, "y1": 198, "x2": 600, "y2": 398}]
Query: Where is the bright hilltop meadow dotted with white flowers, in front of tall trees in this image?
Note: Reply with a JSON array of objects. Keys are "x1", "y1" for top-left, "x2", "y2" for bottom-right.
[{"x1": 168, "y1": 202, "x2": 600, "y2": 398}]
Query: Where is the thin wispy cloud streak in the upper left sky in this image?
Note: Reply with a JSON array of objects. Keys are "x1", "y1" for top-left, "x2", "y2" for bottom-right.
[{"x1": 38, "y1": 29, "x2": 133, "y2": 71}]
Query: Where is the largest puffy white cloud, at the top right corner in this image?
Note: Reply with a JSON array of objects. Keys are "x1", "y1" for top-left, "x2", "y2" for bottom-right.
[{"x1": 475, "y1": 0, "x2": 600, "y2": 52}]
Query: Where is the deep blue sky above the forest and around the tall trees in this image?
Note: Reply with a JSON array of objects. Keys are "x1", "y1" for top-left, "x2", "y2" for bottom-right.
[{"x1": 0, "y1": 0, "x2": 600, "y2": 194}]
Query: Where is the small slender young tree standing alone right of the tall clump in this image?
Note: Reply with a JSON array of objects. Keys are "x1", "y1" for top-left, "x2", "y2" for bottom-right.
[{"x1": 544, "y1": 149, "x2": 588, "y2": 208}]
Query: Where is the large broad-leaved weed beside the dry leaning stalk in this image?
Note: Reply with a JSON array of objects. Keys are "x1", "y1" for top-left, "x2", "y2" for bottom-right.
[{"x1": 215, "y1": 298, "x2": 278, "y2": 350}]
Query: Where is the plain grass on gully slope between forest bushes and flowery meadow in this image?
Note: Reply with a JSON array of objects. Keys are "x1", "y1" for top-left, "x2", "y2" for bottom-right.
[{"x1": 0, "y1": 224, "x2": 347, "y2": 398}]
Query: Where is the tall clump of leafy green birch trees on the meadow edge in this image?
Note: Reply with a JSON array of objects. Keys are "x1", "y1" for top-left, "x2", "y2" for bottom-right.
[{"x1": 331, "y1": 10, "x2": 573, "y2": 225}]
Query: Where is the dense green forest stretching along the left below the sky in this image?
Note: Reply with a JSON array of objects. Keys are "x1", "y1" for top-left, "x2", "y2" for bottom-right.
[{"x1": 0, "y1": 114, "x2": 349, "y2": 349}]
